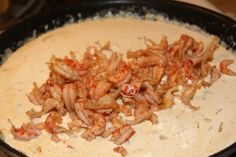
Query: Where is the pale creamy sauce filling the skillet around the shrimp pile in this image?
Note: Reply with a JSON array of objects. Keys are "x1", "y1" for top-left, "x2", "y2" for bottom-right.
[{"x1": 0, "y1": 18, "x2": 236, "y2": 157}]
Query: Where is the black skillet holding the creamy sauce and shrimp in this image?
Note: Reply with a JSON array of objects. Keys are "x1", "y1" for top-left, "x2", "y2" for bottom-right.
[{"x1": 0, "y1": 0, "x2": 236, "y2": 157}]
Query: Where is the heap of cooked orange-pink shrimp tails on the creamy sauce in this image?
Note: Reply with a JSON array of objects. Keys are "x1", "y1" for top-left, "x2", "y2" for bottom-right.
[{"x1": 11, "y1": 34, "x2": 236, "y2": 156}]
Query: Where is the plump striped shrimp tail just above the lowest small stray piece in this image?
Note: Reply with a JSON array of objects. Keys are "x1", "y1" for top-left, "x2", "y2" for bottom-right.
[{"x1": 111, "y1": 124, "x2": 135, "y2": 145}]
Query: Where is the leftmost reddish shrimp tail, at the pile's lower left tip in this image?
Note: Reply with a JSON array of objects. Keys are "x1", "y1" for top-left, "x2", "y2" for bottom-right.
[{"x1": 8, "y1": 120, "x2": 41, "y2": 141}]
